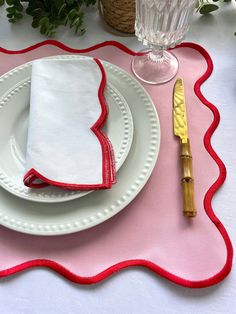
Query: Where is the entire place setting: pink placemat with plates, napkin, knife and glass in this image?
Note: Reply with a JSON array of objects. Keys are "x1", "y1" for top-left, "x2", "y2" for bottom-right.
[{"x1": 0, "y1": 0, "x2": 232, "y2": 288}]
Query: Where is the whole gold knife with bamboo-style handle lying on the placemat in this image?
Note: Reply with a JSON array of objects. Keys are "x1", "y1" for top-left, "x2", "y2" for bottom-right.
[{"x1": 173, "y1": 78, "x2": 197, "y2": 217}]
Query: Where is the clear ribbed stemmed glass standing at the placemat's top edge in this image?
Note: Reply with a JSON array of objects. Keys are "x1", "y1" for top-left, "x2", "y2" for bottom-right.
[{"x1": 132, "y1": 0, "x2": 196, "y2": 84}]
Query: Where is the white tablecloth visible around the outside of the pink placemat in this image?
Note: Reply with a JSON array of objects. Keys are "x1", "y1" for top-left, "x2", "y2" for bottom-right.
[{"x1": 0, "y1": 3, "x2": 236, "y2": 314}]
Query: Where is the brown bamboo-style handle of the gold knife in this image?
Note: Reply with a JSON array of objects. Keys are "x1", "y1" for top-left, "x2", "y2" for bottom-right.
[{"x1": 180, "y1": 139, "x2": 197, "y2": 217}]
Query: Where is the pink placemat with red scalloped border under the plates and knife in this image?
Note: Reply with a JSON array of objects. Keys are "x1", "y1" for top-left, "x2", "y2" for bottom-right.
[{"x1": 0, "y1": 40, "x2": 233, "y2": 288}]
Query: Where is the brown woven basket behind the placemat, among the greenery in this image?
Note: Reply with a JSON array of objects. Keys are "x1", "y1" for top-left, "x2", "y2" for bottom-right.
[{"x1": 99, "y1": 0, "x2": 135, "y2": 34}]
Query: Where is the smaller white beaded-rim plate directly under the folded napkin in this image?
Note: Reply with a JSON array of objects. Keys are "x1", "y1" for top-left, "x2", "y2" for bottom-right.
[{"x1": 0, "y1": 56, "x2": 133, "y2": 203}]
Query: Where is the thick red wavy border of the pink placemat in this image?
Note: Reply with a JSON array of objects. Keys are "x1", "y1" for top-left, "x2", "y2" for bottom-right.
[{"x1": 0, "y1": 40, "x2": 233, "y2": 288}]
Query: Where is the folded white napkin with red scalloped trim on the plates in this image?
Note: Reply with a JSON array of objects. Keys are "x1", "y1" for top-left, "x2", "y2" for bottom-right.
[{"x1": 24, "y1": 58, "x2": 115, "y2": 190}]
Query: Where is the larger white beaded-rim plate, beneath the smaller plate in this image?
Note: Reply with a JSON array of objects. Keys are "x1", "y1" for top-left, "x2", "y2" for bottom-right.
[{"x1": 0, "y1": 56, "x2": 160, "y2": 235}]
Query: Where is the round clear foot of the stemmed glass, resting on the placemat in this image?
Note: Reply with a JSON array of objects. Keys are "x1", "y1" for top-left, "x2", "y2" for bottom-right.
[{"x1": 132, "y1": 49, "x2": 179, "y2": 85}]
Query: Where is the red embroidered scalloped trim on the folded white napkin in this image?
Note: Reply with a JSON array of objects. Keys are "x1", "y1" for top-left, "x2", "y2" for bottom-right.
[{"x1": 23, "y1": 58, "x2": 115, "y2": 190}]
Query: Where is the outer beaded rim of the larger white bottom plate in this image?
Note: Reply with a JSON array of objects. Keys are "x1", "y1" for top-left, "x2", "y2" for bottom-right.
[{"x1": 0, "y1": 55, "x2": 161, "y2": 236}]
